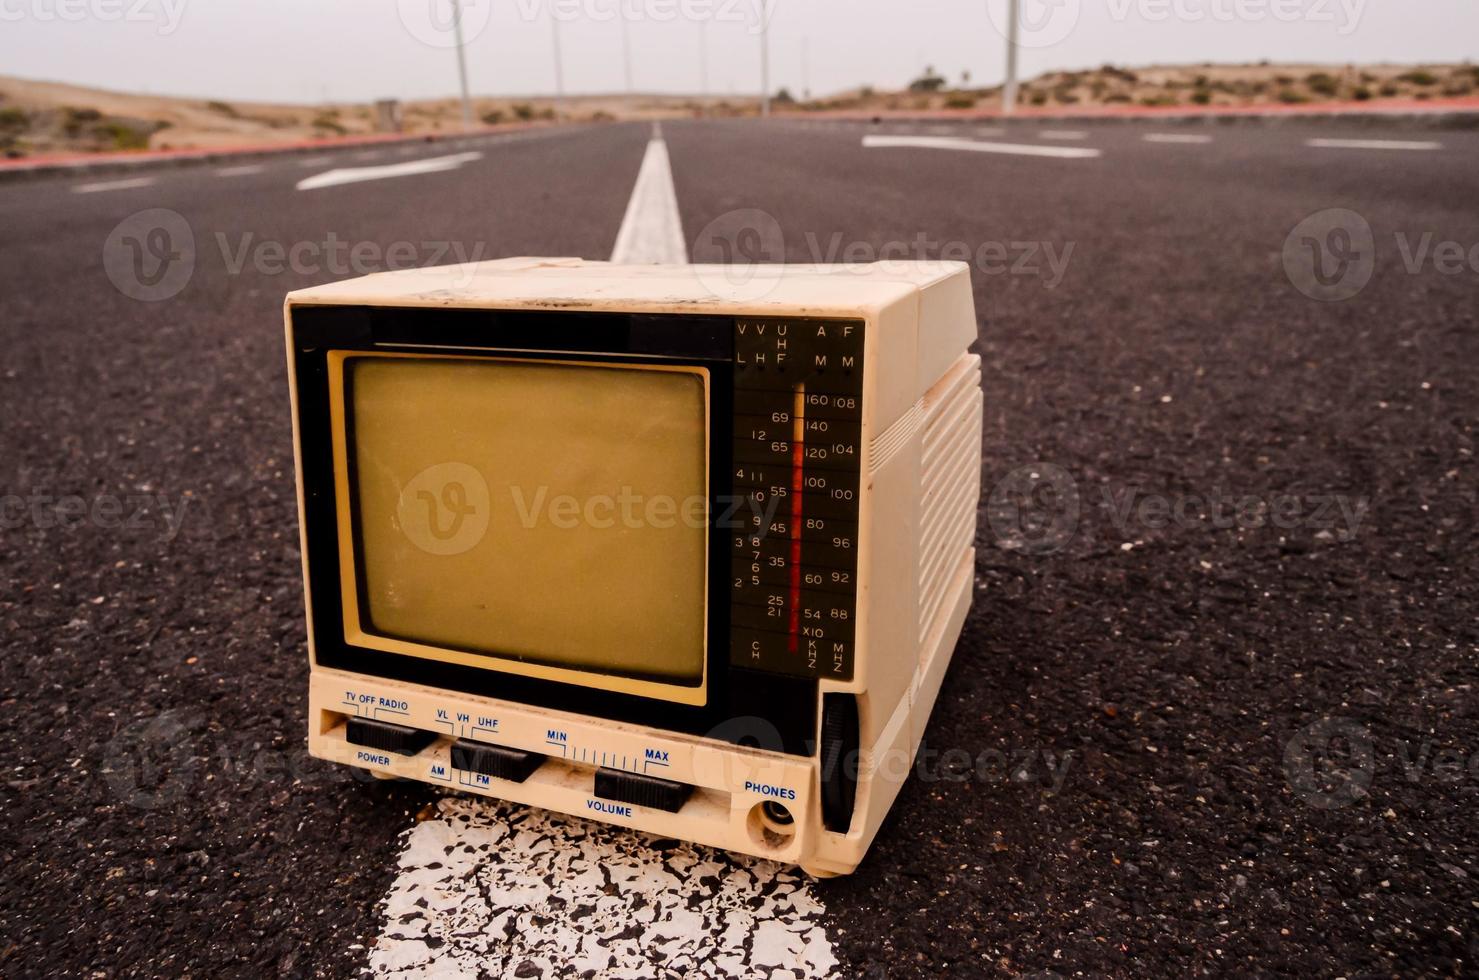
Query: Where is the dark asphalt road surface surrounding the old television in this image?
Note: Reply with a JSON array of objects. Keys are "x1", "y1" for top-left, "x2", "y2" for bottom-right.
[{"x1": 0, "y1": 121, "x2": 1479, "y2": 977}]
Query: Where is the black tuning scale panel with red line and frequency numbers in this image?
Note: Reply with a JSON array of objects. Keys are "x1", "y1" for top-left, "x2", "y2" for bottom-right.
[{"x1": 729, "y1": 318, "x2": 862, "y2": 680}]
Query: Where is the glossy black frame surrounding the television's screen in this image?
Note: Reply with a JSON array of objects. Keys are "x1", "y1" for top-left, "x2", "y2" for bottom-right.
[{"x1": 288, "y1": 304, "x2": 818, "y2": 755}]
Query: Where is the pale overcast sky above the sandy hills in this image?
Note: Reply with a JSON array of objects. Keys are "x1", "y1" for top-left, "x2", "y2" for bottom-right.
[{"x1": 0, "y1": 0, "x2": 1479, "y2": 102}]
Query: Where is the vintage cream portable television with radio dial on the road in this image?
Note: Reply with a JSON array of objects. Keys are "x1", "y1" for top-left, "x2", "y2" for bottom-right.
[{"x1": 285, "y1": 259, "x2": 982, "y2": 875}]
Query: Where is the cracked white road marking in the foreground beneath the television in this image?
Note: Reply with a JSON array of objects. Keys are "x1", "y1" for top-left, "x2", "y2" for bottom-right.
[{"x1": 370, "y1": 797, "x2": 837, "y2": 980}]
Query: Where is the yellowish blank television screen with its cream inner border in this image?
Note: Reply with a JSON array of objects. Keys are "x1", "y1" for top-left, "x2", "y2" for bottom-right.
[{"x1": 331, "y1": 352, "x2": 708, "y2": 701}]
